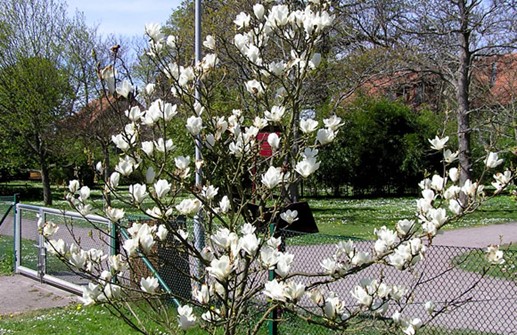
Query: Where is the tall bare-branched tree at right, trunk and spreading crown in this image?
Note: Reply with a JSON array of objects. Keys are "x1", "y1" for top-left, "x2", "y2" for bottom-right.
[{"x1": 352, "y1": 0, "x2": 517, "y2": 184}]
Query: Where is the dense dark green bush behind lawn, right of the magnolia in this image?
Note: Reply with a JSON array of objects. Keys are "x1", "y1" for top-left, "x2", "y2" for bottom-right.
[{"x1": 317, "y1": 98, "x2": 440, "y2": 195}]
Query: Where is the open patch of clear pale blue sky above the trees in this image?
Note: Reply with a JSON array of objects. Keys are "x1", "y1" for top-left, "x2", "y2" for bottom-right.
[{"x1": 65, "y1": 0, "x2": 181, "y2": 37}]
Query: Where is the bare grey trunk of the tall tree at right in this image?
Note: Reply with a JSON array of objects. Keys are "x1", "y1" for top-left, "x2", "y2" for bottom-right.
[{"x1": 456, "y1": 1, "x2": 472, "y2": 185}]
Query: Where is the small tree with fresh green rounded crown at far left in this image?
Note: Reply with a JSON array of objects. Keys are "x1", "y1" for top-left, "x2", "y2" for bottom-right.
[{"x1": 0, "y1": 57, "x2": 72, "y2": 204}]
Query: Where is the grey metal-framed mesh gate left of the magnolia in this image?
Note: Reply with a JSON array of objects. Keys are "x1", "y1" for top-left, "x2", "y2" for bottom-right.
[{"x1": 14, "y1": 204, "x2": 114, "y2": 294}]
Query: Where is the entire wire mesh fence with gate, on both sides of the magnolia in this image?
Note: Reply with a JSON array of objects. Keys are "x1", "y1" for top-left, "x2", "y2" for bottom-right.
[{"x1": 6, "y1": 206, "x2": 517, "y2": 335}]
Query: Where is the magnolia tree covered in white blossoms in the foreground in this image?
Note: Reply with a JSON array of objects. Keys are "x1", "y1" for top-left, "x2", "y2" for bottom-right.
[{"x1": 42, "y1": 0, "x2": 513, "y2": 334}]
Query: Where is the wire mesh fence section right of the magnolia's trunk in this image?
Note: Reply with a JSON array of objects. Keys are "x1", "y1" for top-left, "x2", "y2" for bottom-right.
[{"x1": 278, "y1": 233, "x2": 517, "y2": 335}]
